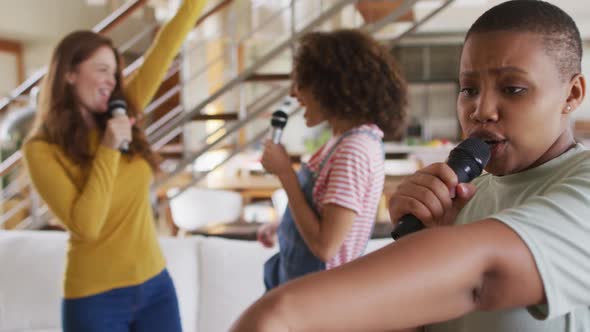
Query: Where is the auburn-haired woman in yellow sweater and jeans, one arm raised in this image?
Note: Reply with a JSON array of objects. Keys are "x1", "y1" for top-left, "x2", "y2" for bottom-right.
[{"x1": 23, "y1": 0, "x2": 206, "y2": 332}]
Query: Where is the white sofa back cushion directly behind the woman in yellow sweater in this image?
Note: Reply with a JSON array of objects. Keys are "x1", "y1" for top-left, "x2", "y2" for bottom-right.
[{"x1": 0, "y1": 231, "x2": 200, "y2": 332}]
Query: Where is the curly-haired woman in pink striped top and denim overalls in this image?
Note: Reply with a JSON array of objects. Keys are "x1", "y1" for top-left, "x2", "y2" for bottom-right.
[{"x1": 258, "y1": 30, "x2": 406, "y2": 290}]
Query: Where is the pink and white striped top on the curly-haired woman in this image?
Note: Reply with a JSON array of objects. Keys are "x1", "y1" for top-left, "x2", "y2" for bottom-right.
[{"x1": 308, "y1": 125, "x2": 384, "y2": 270}]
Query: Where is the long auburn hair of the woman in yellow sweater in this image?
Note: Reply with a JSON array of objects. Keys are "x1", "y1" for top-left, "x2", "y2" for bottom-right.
[{"x1": 27, "y1": 31, "x2": 159, "y2": 170}]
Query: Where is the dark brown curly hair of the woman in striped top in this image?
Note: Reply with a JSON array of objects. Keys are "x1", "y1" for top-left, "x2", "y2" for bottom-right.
[{"x1": 293, "y1": 29, "x2": 407, "y2": 135}]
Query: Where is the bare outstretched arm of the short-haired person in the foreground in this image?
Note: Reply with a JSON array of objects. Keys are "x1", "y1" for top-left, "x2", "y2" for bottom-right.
[{"x1": 232, "y1": 220, "x2": 544, "y2": 332}]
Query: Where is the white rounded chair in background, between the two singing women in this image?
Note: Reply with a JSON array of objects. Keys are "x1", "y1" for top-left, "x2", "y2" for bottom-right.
[{"x1": 168, "y1": 188, "x2": 242, "y2": 233}]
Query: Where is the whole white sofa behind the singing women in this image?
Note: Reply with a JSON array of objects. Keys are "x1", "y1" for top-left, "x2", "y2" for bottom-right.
[{"x1": 0, "y1": 231, "x2": 391, "y2": 332}]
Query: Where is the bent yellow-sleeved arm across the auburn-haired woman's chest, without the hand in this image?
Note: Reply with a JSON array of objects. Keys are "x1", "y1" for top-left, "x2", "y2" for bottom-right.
[{"x1": 23, "y1": 141, "x2": 121, "y2": 241}]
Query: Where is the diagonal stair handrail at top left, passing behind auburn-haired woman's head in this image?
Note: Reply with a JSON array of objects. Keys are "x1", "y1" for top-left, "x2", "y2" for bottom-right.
[{"x1": 0, "y1": 0, "x2": 148, "y2": 112}]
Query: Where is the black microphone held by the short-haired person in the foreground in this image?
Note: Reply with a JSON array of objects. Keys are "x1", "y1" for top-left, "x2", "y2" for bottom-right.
[{"x1": 391, "y1": 137, "x2": 490, "y2": 240}]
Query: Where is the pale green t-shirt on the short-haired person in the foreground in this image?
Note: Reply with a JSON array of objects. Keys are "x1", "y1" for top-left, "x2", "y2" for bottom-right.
[{"x1": 426, "y1": 144, "x2": 590, "y2": 332}]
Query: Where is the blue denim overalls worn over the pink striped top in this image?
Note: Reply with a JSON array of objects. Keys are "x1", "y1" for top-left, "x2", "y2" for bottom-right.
[{"x1": 264, "y1": 129, "x2": 383, "y2": 291}]
